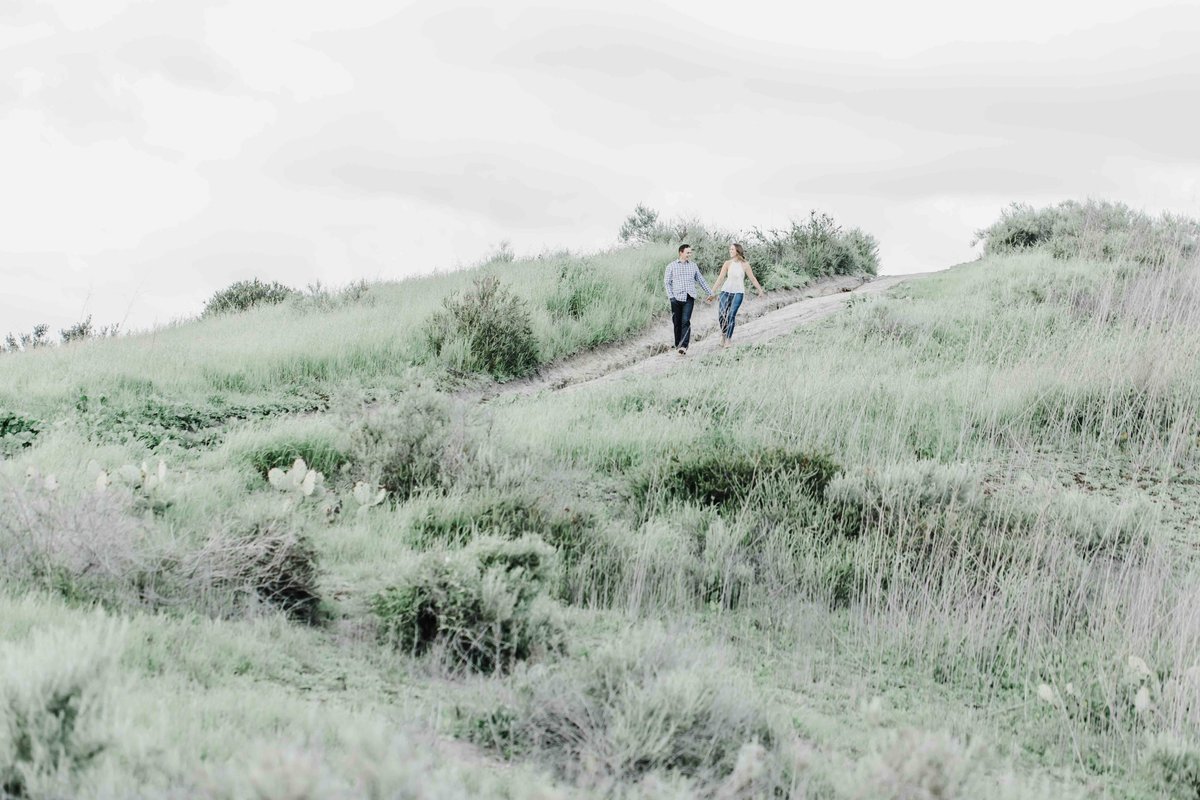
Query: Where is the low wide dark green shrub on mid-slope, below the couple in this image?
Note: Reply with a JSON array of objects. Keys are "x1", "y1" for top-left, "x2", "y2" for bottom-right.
[{"x1": 635, "y1": 449, "x2": 841, "y2": 506}]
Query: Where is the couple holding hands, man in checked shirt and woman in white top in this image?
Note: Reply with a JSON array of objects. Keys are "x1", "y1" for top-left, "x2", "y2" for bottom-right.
[{"x1": 662, "y1": 243, "x2": 762, "y2": 355}]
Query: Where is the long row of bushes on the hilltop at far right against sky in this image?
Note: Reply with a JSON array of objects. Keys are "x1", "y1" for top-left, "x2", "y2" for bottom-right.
[{"x1": 972, "y1": 200, "x2": 1200, "y2": 266}]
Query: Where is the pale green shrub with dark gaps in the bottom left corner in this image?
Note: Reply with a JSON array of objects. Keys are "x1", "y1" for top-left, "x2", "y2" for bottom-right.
[{"x1": 0, "y1": 616, "x2": 125, "y2": 798}]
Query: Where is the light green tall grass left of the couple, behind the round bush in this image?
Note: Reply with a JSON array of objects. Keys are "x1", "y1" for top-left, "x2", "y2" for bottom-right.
[{"x1": 0, "y1": 245, "x2": 673, "y2": 419}]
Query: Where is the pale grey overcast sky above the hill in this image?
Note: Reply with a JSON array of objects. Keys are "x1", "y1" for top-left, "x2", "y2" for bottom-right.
[{"x1": 0, "y1": 0, "x2": 1200, "y2": 335}]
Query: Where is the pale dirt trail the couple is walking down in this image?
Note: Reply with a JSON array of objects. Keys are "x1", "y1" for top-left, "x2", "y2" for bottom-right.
[{"x1": 475, "y1": 275, "x2": 912, "y2": 401}]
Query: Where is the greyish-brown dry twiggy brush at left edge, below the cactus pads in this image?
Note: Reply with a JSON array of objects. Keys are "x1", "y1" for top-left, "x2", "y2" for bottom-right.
[{"x1": 0, "y1": 479, "x2": 320, "y2": 622}]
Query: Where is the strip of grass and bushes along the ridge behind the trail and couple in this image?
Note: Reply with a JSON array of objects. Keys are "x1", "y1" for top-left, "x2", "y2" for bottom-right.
[{"x1": 0, "y1": 206, "x2": 877, "y2": 462}]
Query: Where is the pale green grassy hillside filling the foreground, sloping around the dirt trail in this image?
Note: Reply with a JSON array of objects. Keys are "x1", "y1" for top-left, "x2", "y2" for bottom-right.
[{"x1": 0, "y1": 208, "x2": 1200, "y2": 799}]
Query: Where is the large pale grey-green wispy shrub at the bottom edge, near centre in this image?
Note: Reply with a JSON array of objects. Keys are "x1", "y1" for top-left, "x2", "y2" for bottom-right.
[{"x1": 460, "y1": 631, "x2": 794, "y2": 798}]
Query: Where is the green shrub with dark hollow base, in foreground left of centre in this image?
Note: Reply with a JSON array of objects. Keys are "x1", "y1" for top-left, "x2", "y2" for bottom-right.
[{"x1": 372, "y1": 536, "x2": 563, "y2": 672}]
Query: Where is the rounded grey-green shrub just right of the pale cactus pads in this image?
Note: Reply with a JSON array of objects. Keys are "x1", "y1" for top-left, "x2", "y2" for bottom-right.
[{"x1": 349, "y1": 386, "x2": 456, "y2": 500}]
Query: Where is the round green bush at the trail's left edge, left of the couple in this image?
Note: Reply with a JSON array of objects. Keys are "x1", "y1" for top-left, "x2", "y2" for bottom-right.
[{"x1": 426, "y1": 275, "x2": 539, "y2": 380}]
